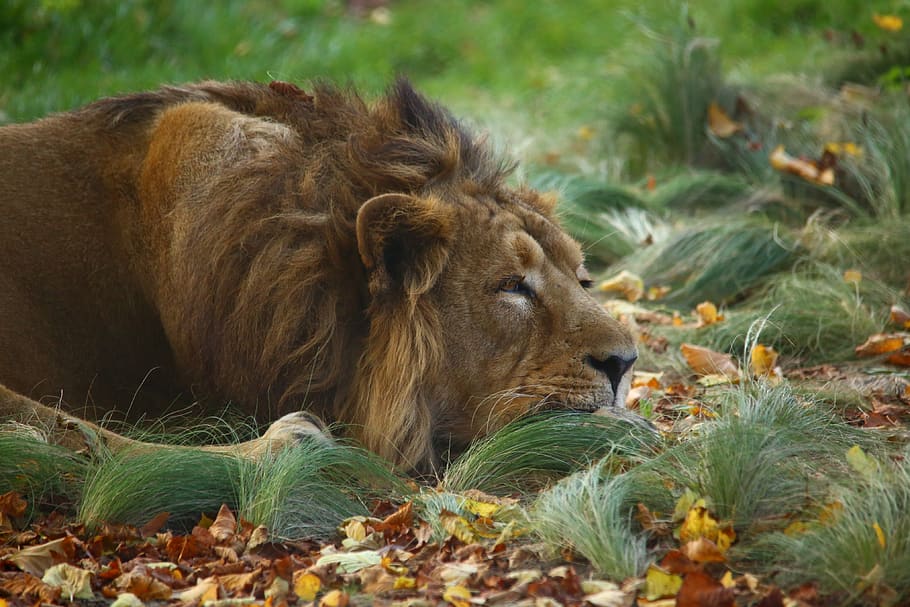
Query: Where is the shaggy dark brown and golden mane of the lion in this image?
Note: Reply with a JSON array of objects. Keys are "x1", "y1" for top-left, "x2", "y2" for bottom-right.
[{"x1": 82, "y1": 79, "x2": 511, "y2": 466}]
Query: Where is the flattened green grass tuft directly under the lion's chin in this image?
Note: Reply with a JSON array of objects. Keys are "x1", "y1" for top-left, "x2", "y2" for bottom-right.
[{"x1": 442, "y1": 411, "x2": 659, "y2": 495}]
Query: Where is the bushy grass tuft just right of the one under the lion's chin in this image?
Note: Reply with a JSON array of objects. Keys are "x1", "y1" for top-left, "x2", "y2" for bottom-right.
[{"x1": 660, "y1": 382, "x2": 875, "y2": 529}]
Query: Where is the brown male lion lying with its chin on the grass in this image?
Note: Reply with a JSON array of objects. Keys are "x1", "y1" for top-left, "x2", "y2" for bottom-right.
[{"x1": 0, "y1": 79, "x2": 637, "y2": 469}]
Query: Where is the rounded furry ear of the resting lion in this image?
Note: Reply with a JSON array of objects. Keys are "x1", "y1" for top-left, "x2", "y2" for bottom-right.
[{"x1": 357, "y1": 194, "x2": 453, "y2": 296}]
